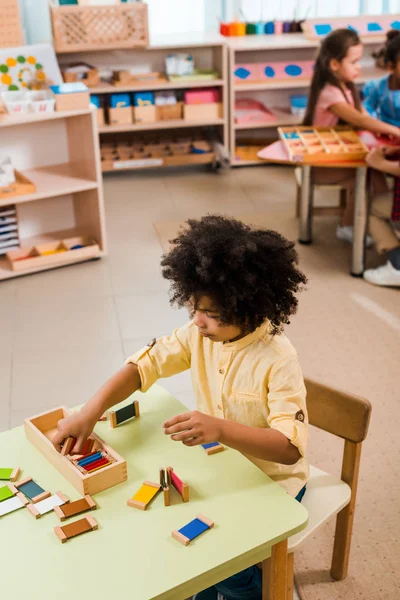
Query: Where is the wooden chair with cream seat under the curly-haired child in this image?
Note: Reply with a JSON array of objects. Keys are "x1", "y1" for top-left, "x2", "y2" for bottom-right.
[{"x1": 262, "y1": 379, "x2": 371, "y2": 600}]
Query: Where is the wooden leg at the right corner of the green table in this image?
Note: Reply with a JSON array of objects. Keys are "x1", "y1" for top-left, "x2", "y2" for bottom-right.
[{"x1": 262, "y1": 540, "x2": 288, "y2": 600}]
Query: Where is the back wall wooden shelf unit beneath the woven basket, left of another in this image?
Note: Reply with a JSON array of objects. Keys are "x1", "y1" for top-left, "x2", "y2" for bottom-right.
[{"x1": 58, "y1": 34, "x2": 228, "y2": 171}]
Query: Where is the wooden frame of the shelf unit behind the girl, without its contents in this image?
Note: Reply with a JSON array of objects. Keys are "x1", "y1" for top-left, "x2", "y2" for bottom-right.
[{"x1": 227, "y1": 33, "x2": 384, "y2": 166}]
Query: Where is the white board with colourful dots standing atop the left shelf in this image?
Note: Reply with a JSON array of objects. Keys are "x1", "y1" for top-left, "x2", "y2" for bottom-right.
[{"x1": 0, "y1": 44, "x2": 63, "y2": 92}]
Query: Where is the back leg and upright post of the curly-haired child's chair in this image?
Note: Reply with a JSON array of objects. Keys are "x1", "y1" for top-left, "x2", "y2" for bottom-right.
[{"x1": 331, "y1": 440, "x2": 361, "y2": 581}]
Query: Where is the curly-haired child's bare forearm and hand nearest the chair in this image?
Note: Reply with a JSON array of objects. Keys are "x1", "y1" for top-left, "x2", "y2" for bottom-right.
[{"x1": 163, "y1": 410, "x2": 301, "y2": 465}]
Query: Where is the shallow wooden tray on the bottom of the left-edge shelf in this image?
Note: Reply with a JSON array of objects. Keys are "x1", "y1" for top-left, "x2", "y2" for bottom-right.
[{"x1": 6, "y1": 236, "x2": 100, "y2": 271}]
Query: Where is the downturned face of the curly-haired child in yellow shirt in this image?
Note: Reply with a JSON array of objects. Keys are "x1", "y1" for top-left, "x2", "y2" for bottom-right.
[{"x1": 192, "y1": 296, "x2": 244, "y2": 342}]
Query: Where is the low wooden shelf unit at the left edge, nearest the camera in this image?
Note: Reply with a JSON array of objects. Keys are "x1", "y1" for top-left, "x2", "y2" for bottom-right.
[{"x1": 0, "y1": 109, "x2": 107, "y2": 280}]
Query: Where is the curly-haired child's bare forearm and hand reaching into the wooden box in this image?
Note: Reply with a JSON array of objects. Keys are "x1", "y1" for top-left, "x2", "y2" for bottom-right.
[{"x1": 52, "y1": 363, "x2": 141, "y2": 453}]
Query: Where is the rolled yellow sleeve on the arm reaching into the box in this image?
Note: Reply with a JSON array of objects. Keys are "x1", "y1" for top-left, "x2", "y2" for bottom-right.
[{"x1": 125, "y1": 323, "x2": 192, "y2": 392}]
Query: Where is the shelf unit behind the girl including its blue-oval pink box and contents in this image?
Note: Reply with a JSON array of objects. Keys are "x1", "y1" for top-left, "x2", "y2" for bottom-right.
[{"x1": 227, "y1": 33, "x2": 384, "y2": 166}]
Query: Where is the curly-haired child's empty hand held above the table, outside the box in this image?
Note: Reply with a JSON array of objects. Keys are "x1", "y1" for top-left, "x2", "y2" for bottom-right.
[{"x1": 163, "y1": 410, "x2": 221, "y2": 446}]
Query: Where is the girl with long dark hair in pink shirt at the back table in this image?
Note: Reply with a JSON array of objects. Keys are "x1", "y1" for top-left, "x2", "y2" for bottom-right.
[{"x1": 303, "y1": 29, "x2": 400, "y2": 243}]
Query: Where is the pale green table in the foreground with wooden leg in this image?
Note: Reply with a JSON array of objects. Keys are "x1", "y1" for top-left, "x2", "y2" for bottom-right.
[{"x1": 0, "y1": 385, "x2": 307, "y2": 600}]
